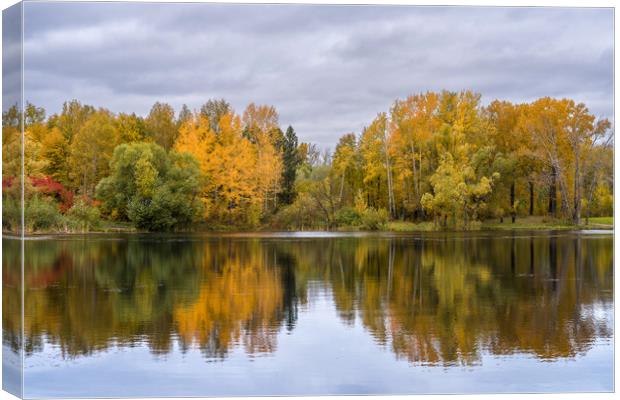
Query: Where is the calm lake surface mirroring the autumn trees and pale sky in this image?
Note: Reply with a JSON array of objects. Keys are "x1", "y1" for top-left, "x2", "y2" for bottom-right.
[{"x1": 3, "y1": 231, "x2": 614, "y2": 398}]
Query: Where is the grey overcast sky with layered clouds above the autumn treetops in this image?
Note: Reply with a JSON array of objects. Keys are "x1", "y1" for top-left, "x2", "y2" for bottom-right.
[{"x1": 19, "y1": 3, "x2": 614, "y2": 148}]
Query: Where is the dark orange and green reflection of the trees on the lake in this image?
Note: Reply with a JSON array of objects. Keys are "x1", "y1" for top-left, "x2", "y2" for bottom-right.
[{"x1": 3, "y1": 234, "x2": 613, "y2": 366}]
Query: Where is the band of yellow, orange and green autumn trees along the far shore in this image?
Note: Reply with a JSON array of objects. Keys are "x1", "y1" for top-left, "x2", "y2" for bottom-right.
[{"x1": 2, "y1": 91, "x2": 613, "y2": 232}]
